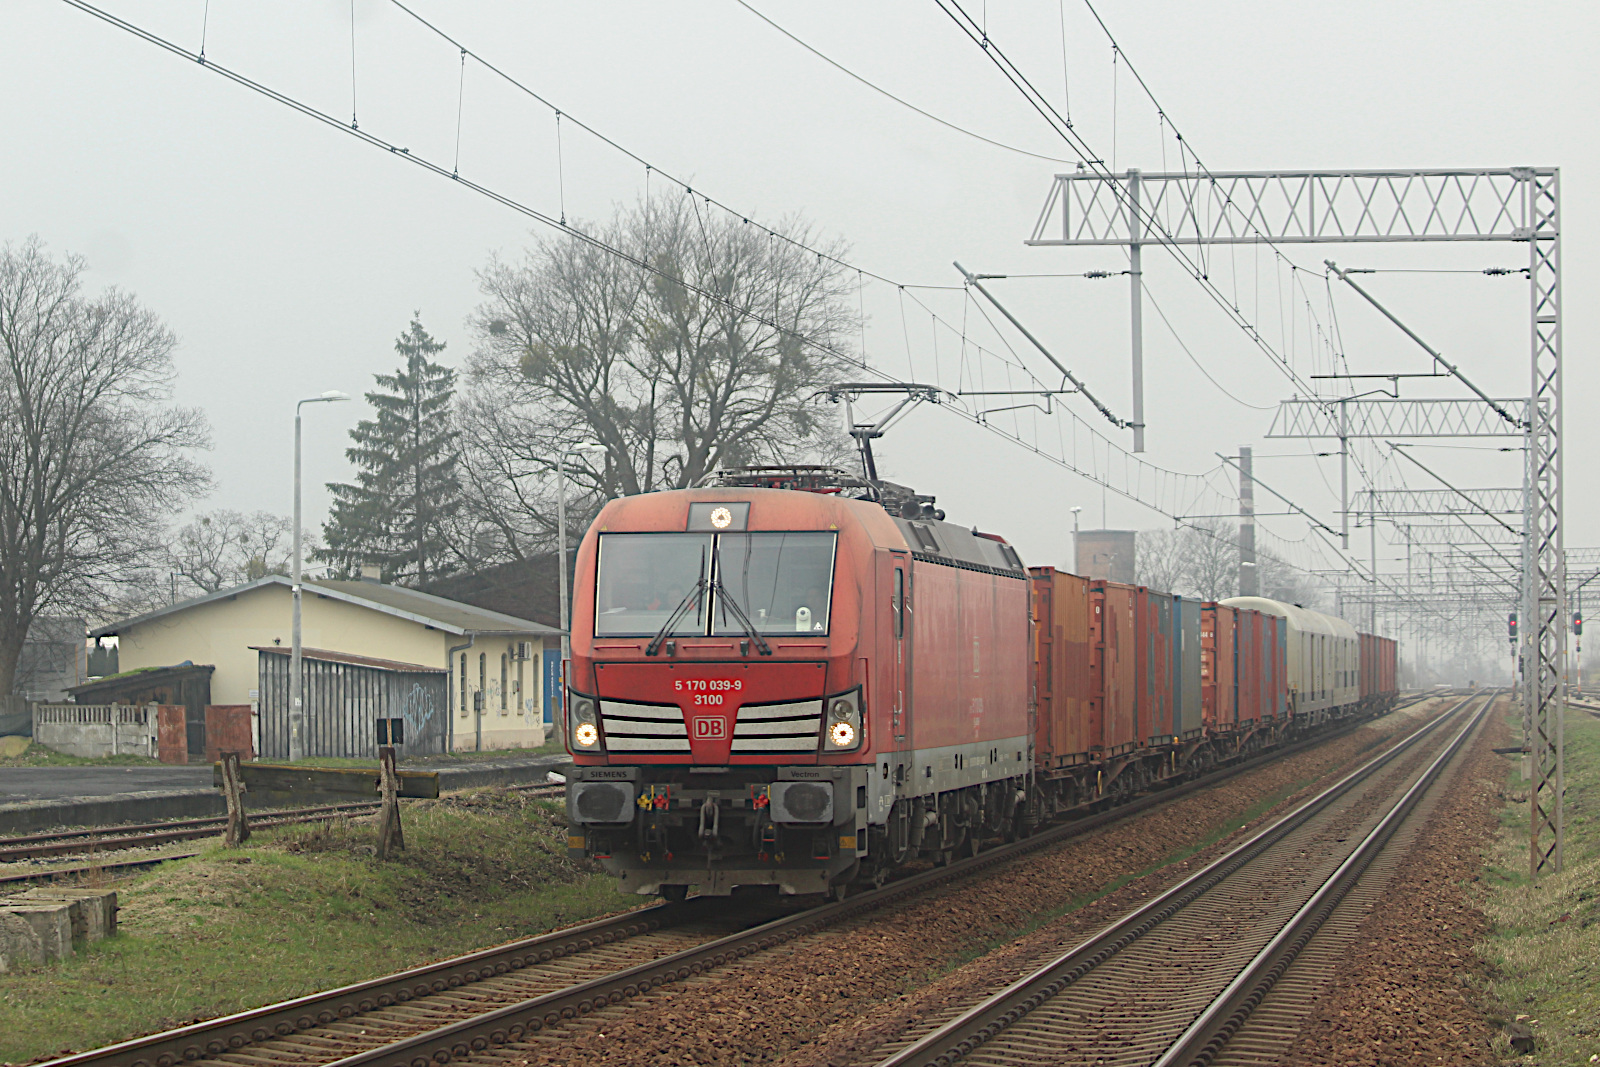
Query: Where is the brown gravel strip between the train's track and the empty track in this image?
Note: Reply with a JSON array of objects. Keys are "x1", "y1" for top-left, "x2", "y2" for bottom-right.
[{"x1": 480, "y1": 700, "x2": 1452, "y2": 1067}]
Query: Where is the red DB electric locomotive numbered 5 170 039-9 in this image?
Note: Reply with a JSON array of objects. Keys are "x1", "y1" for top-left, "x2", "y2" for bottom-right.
[{"x1": 568, "y1": 469, "x2": 1032, "y2": 897}]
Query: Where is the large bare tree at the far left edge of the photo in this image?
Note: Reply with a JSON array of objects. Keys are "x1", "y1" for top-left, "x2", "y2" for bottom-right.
[{"x1": 0, "y1": 238, "x2": 208, "y2": 693}]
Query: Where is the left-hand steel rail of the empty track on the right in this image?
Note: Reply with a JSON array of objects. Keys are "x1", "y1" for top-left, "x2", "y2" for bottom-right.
[{"x1": 877, "y1": 696, "x2": 1477, "y2": 1067}]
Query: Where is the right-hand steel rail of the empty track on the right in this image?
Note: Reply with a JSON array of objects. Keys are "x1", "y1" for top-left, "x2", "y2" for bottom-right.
[{"x1": 1155, "y1": 694, "x2": 1494, "y2": 1067}]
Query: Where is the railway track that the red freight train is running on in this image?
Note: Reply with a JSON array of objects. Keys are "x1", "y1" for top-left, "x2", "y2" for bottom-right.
[{"x1": 34, "y1": 697, "x2": 1452, "y2": 1067}]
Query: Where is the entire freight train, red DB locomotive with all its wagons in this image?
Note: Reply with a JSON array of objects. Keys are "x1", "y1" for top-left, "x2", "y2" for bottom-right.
[{"x1": 566, "y1": 467, "x2": 1395, "y2": 899}]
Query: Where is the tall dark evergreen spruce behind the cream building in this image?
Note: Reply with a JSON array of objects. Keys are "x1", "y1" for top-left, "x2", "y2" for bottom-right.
[{"x1": 317, "y1": 312, "x2": 461, "y2": 585}]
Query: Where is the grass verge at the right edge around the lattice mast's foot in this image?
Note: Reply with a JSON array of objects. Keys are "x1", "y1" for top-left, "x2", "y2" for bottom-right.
[{"x1": 1480, "y1": 710, "x2": 1600, "y2": 1065}]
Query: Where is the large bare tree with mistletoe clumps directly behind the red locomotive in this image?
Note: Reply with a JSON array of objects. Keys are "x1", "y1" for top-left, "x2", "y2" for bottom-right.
[{"x1": 459, "y1": 197, "x2": 856, "y2": 557}]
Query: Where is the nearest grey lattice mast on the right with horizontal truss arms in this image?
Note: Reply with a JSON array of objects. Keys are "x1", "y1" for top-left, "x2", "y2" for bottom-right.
[{"x1": 1027, "y1": 166, "x2": 1566, "y2": 873}]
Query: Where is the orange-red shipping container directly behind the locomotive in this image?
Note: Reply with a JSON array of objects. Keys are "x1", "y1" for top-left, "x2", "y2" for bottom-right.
[{"x1": 1030, "y1": 566, "x2": 1101, "y2": 766}]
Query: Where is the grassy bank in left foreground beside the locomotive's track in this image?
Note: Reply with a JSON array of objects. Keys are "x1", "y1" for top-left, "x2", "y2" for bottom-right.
[{"x1": 0, "y1": 790, "x2": 640, "y2": 1062}]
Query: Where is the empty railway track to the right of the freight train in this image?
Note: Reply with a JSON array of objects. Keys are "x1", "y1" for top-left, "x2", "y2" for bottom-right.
[{"x1": 878, "y1": 693, "x2": 1496, "y2": 1067}]
